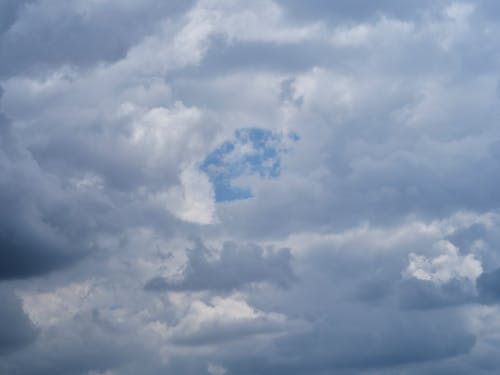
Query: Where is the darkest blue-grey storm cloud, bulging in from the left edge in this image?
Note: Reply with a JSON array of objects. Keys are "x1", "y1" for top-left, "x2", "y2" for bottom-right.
[{"x1": 0, "y1": 97, "x2": 104, "y2": 280}]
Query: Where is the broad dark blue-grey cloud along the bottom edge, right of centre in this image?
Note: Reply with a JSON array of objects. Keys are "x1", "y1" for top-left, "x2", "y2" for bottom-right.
[{"x1": 224, "y1": 310, "x2": 475, "y2": 374}]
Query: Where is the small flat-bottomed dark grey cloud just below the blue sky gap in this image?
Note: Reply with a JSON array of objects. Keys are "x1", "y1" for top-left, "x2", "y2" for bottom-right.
[{"x1": 144, "y1": 241, "x2": 295, "y2": 291}]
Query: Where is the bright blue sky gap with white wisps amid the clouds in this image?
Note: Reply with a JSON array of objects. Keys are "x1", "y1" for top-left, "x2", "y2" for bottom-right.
[{"x1": 200, "y1": 128, "x2": 299, "y2": 202}]
